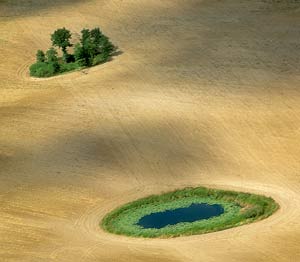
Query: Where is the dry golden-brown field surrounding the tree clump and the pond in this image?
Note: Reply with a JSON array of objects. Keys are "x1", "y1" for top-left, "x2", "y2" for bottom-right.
[{"x1": 0, "y1": 0, "x2": 300, "y2": 262}]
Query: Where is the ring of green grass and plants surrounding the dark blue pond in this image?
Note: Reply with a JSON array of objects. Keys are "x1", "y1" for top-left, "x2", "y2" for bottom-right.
[{"x1": 100, "y1": 187, "x2": 279, "y2": 238}]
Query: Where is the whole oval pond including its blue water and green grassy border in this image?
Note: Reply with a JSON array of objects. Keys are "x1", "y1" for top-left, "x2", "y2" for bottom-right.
[{"x1": 100, "y1": 187, "x2": 279, "y2": 238}]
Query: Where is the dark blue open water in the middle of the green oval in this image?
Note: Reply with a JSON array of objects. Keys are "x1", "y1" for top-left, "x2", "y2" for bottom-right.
[{"x1": 137, "y1": 203, "x2": 224, "y2": 229}]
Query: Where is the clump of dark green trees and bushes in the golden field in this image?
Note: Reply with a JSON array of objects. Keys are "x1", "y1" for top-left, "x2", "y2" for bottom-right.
[{"x1": 29, "y1": 28, "x2": 117, "y2": 77}]
